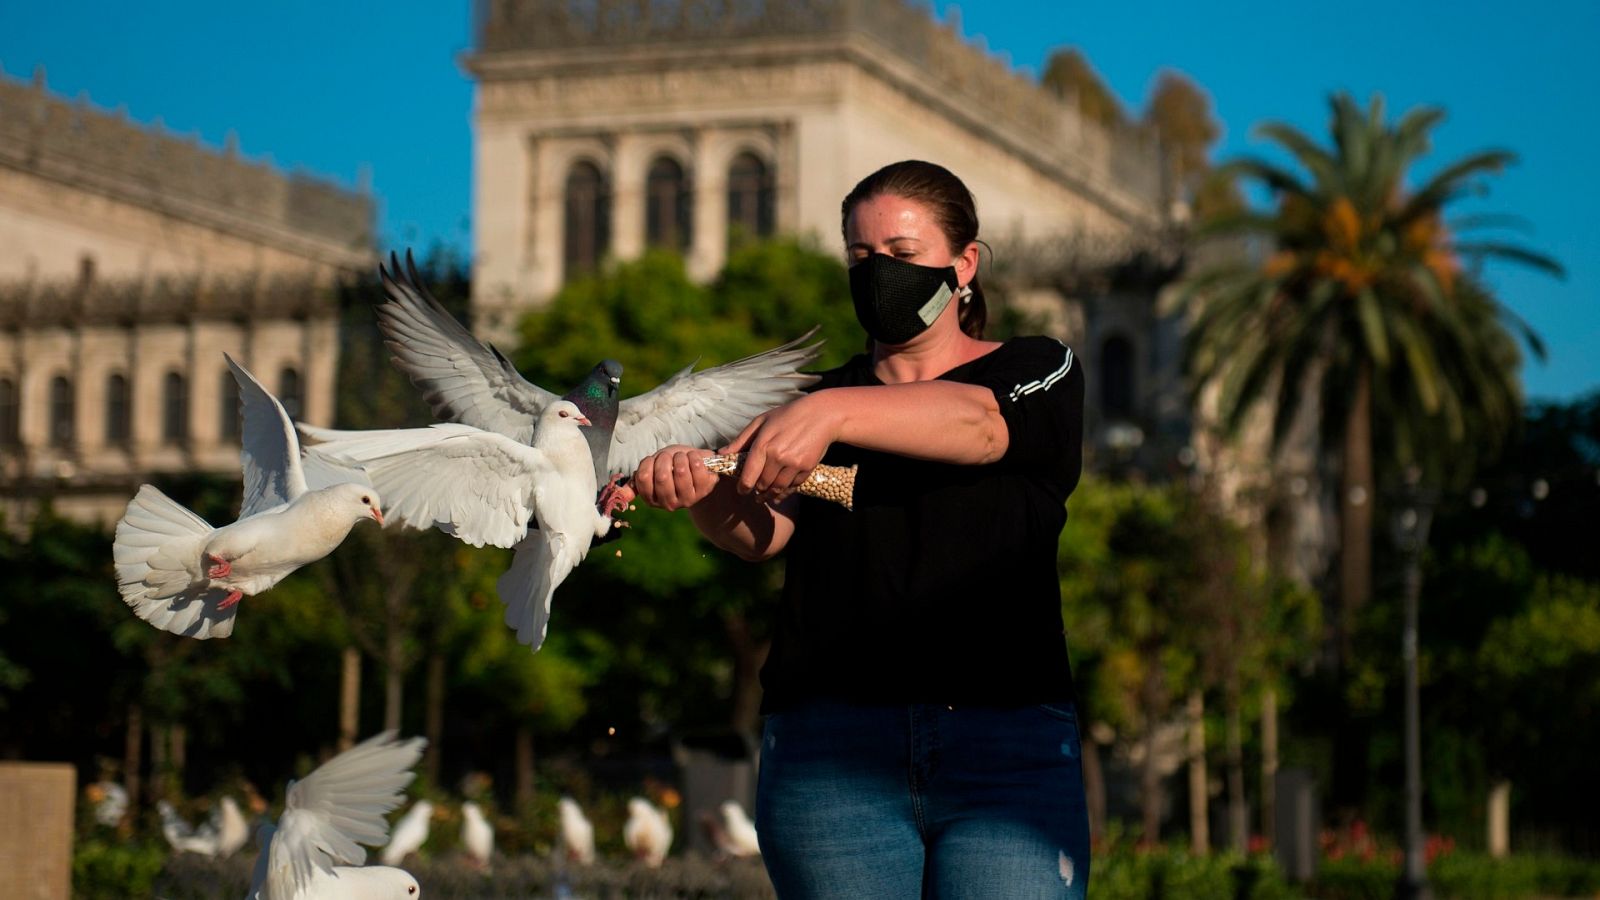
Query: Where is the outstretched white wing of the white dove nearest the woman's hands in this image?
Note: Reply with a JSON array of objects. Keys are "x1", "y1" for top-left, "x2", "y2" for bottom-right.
[{"x1": 301, "y1": 424, "x2": 560, "y2": 548}]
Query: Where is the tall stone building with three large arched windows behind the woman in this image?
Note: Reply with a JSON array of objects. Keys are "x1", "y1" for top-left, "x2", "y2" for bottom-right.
[{"x1": 466, "y1": 0, "x2": 1184, "y2": 450}]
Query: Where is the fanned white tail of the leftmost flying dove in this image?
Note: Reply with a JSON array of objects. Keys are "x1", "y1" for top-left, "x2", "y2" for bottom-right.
[{"x1": 112, "y1": 485, "x2": 234, "y2": 641}]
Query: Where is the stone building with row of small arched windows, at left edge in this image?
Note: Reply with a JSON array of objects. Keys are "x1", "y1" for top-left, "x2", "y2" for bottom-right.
[{"x1": 0, "y1": 72, "x2": 374, "y2": 525}]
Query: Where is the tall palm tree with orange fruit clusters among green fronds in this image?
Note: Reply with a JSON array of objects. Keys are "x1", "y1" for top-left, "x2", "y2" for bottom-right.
[{"x1": 1179, "y1": 94, "x2": 1562, "y2": 665}]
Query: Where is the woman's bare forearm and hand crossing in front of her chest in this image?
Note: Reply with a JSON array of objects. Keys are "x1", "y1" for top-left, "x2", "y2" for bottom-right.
[{"x1": 725, "y1": 381, "x2": 1010, "y2": 493}]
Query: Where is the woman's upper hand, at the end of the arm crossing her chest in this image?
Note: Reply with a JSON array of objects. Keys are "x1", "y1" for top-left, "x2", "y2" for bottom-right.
[{"x1": 720, "y1": 392, "x2": 838, "y2": 501}]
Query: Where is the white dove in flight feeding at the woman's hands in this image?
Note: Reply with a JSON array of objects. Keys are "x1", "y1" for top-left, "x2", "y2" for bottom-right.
[{"x1": 301, "y1": 400, "x2": 614, "y2": 650}]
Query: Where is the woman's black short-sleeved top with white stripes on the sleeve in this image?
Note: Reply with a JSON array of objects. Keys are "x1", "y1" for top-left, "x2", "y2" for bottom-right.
[{"x1": 762, "y1": 336, "x2": 1083, "y2": 713}]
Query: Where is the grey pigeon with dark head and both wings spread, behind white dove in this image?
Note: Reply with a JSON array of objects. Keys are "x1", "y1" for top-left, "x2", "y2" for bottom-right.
[{"x1": 376, "y1": 245, "x2": 822, "y2": 485}]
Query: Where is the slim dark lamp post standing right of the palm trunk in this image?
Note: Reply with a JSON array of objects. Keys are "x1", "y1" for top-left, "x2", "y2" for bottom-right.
[{"x1": 1394, "y1": 466, "x2": 1435, "y2": 900}]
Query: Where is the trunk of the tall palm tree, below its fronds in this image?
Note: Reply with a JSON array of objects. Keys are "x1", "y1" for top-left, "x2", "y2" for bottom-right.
[{"x1": 1338, "y1": 360, "x2": 1376, "y2": 669}]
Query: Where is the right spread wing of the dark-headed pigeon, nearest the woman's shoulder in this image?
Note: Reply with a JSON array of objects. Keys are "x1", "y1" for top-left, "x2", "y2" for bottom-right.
[{"x1": 604, "y1": 328, "x2": 821, "y2": 470}]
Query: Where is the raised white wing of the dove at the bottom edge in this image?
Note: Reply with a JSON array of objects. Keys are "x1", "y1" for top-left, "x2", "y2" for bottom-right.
[{"x1": 266, "y1": 732, "x2": 427, "y2": 898}]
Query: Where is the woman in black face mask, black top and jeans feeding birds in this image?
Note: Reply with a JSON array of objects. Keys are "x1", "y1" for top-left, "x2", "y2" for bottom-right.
[{"x1": 634, "y1": 162, "x2": 1090, "y2": 898}]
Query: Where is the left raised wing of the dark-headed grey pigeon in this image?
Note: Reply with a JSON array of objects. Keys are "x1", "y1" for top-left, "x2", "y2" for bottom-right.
[{"x1": 376, "y1": 251, "x2": 557, "y2": 438}]
